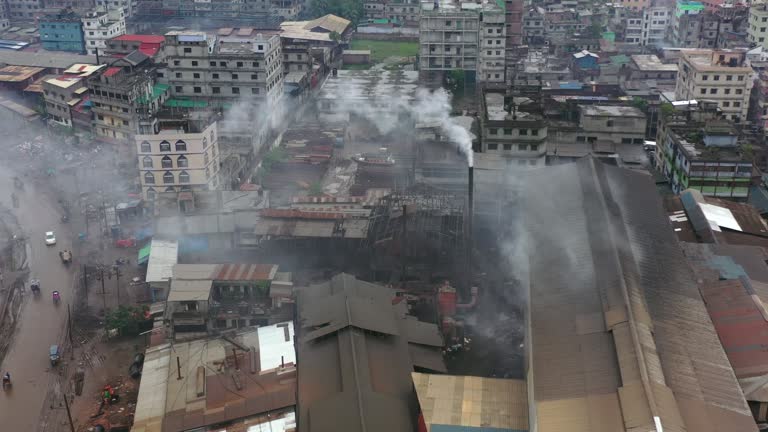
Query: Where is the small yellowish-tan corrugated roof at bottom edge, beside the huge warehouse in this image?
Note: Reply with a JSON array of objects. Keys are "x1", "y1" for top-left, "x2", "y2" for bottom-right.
[{"x1": 411, "y1": 372, "x2": 528, "y2": 432}]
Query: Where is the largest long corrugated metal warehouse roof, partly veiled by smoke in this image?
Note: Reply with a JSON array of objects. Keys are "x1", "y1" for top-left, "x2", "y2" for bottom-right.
[{"x1": 521, "y1": 158, "x2": 756, "y2": 432}]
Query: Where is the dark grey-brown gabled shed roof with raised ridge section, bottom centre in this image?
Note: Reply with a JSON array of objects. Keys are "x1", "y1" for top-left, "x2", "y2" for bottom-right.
[{"x1": 297, "y1": 274, "x2": 448, "y2": 432}]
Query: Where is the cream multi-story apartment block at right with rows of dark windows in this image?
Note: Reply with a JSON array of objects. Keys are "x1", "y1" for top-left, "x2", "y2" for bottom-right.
[{"x1": 675, "y1": 50, "x2": 753, "y2": 122}]
